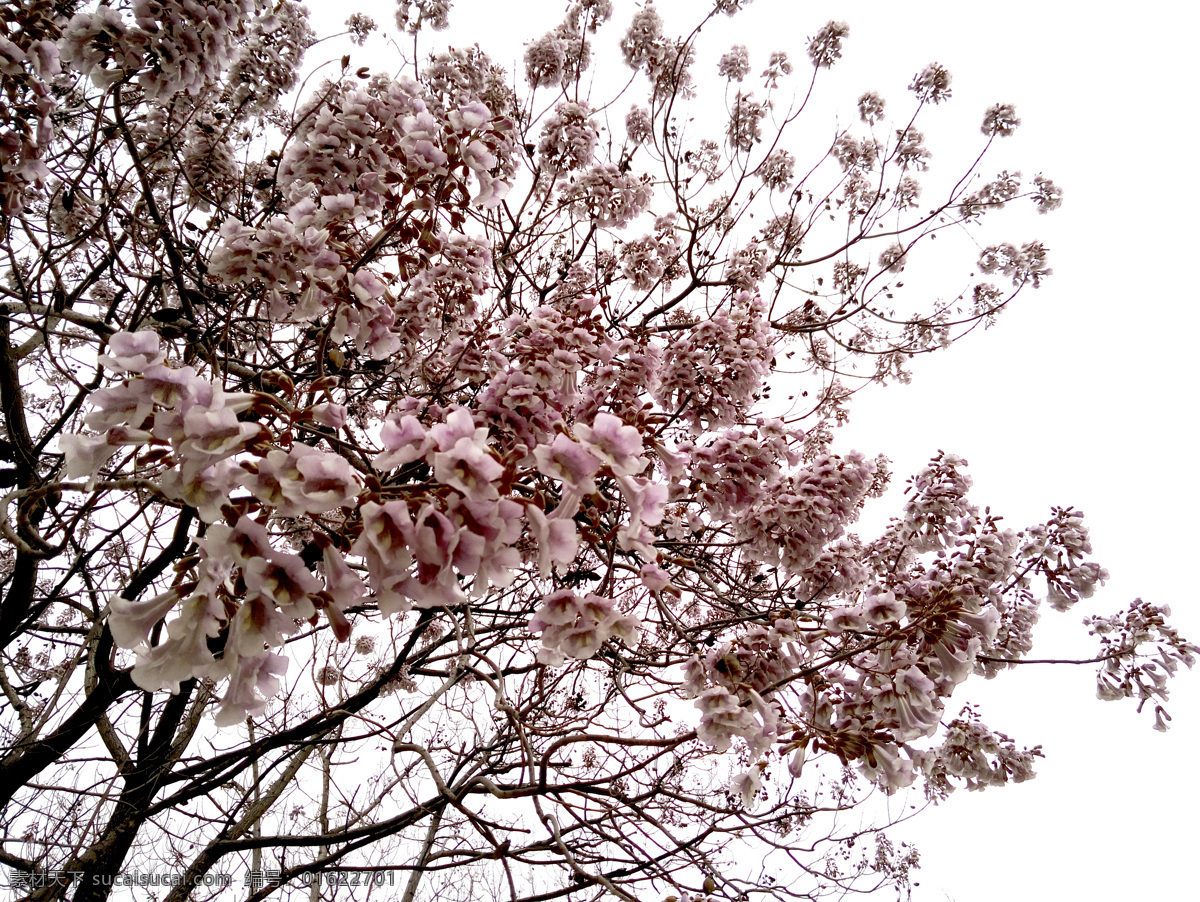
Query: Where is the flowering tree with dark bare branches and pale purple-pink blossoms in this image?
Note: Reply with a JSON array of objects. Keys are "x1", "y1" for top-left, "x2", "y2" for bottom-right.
[{"x1": 0, "y1": 0, "x2": 1196, "y2": 900}]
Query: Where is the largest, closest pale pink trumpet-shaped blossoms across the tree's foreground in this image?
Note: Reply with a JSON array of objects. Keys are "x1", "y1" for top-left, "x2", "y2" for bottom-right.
[{"x1": 60, "y1": 331, "x2": 686, "y2": 705}]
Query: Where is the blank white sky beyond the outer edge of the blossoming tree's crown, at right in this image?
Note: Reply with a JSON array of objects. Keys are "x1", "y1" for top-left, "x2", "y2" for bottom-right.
[{"x1": 311, "y1": 0, "x2": 1200, "y2": 902}]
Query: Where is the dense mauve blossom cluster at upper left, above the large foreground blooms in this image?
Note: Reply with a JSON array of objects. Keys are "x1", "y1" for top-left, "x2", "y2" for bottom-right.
[{"x1": 210, "y1": 74, "x2": 511, "y2": 360}]
